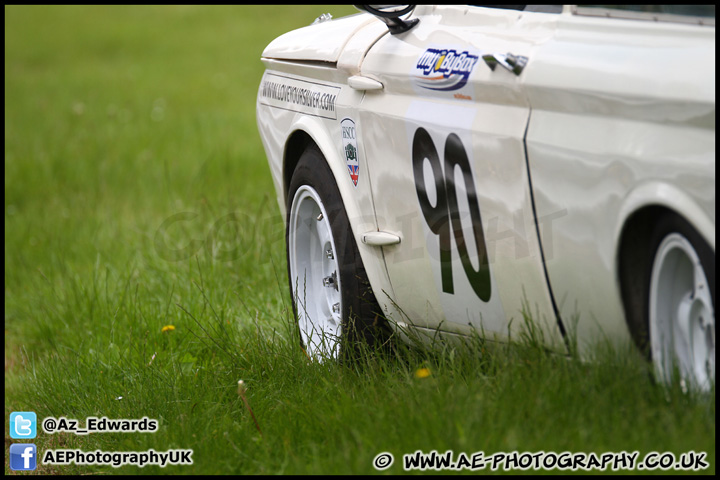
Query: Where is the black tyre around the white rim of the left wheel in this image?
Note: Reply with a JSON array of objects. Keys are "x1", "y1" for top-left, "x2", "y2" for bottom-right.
[{"x1": 285, "y1": 144, "x2": 390, "y2": 358}]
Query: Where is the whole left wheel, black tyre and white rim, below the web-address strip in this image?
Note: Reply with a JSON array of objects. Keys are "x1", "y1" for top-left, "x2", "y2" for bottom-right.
[{"x1": 286, "y1": 145, "x2": 387, "y2": 361}]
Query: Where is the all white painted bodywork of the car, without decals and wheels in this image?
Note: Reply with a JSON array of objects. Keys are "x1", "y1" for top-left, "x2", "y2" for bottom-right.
[{"x1": 257, "y1": 6, "x2": 715, "y2": 356}]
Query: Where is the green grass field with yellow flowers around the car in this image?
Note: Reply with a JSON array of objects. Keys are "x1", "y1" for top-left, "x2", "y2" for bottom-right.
[{"x1": 5, "y1": 6, "x2": 715, "y2": 474}]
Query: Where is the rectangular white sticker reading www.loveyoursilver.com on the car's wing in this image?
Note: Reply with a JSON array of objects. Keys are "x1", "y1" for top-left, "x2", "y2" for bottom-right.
[{"x1": 260, "y1": 73, "x2": 340, "y2": 120}]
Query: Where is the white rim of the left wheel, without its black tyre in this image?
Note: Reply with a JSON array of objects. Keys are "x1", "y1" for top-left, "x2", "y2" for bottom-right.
[{"x1": 288, "y1": 185, "x2": 342, "y2": 361}]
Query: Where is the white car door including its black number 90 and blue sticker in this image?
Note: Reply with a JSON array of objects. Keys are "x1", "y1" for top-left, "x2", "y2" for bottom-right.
[{"x1": 359, "y1": 7, "x2": 561, "y2": 345}]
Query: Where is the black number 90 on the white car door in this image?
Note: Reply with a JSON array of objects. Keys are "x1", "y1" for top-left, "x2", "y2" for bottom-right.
[{"x1": 412, "y1": 127, "x2": 491, "y2": 302}]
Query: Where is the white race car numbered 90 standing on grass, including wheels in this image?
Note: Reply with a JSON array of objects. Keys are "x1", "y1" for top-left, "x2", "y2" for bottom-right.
[{"x1": 257, "y1": 5, "x2": 715, "y2": 389}]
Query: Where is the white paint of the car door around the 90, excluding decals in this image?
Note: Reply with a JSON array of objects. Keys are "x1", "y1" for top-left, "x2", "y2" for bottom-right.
[{"x1": 359, "y1": 7, "x2": 563, "y2": 349}]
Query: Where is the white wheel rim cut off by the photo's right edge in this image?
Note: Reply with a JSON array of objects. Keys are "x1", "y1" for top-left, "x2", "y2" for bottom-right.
[{"x1": 649, "y1": 233, "x2": 715, "y2": 390}]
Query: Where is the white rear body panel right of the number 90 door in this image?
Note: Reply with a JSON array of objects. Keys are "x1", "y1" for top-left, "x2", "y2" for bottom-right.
[{"x1": 524, "y1": 11, "x2": 715, "y2": 349}]
